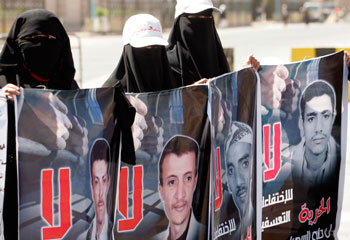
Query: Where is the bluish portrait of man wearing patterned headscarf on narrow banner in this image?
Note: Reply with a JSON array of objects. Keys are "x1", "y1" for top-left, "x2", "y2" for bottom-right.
[{"x1": 225, "y1": 122, "x2": 254, "y2": 238}]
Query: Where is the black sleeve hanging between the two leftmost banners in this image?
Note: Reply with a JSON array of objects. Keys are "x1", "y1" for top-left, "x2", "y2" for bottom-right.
[{"x1": 115, "y1": 82, "x2": 136, "y2": 165}]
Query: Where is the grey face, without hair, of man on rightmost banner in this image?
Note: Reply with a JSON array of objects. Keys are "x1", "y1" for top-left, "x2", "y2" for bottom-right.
[{"x1": 303, "y1": 94, "x2": 334, "y2": 155}]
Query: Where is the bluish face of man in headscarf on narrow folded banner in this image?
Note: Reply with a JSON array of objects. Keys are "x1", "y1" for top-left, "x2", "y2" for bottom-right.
[{"x1": 226, "y1": 142, "x2": 251, "y2": 214}]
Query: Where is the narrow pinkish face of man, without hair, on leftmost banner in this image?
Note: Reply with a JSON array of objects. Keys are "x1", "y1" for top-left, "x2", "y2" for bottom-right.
[{"x1": 91, "y1": 159, "x2": 109, "y2": 224}]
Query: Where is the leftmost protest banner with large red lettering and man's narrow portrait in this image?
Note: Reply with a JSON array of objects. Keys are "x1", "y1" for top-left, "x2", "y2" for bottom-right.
[{"x1": 17, "y1": 88, "x2": 132, "y2": 239}]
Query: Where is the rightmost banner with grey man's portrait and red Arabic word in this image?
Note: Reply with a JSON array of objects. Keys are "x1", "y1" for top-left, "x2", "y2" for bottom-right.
[{"x1": 259, "y1": 52, "x2": 347, "y2": 240}]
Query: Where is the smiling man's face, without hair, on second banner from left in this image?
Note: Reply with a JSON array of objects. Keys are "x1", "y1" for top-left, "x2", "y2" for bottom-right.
[{"x1": 159, "y1": 151, "x2": 197, "y2": 229}]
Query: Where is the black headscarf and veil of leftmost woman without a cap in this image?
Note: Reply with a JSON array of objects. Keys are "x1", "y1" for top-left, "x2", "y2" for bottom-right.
[{"x1": 0, "y1": 9, "x2": 78, "y2": 90}]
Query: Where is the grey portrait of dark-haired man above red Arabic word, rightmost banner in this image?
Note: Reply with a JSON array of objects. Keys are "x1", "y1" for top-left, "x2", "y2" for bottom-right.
[{"x1": 292, "y1": 80, "x2": 340, "y2": 186}]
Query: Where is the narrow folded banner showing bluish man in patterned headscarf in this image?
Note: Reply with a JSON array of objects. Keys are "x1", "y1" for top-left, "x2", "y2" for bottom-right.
[{"x1": 209, "y1": 68, "x2": 261, "y2": 240}]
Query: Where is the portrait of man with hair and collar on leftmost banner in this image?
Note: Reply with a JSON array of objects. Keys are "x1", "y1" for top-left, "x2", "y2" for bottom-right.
[{"x1": 79, "y1": 139, "x2": 113, "y2": 240}]
